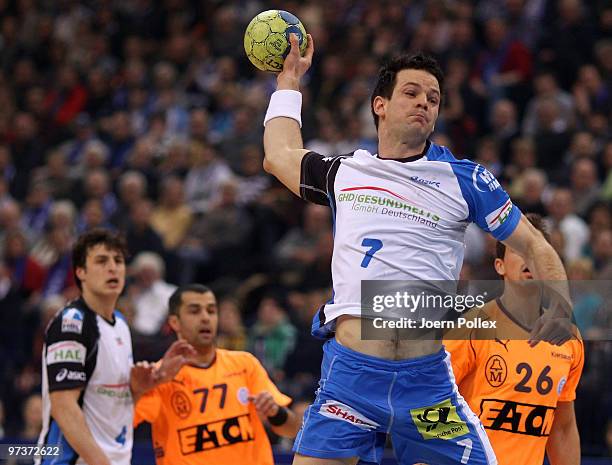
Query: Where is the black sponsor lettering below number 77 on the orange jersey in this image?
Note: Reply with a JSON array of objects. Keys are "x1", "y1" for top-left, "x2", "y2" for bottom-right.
[{"x1": 177, "y1": 413, "x2": 255, "y2": 455}]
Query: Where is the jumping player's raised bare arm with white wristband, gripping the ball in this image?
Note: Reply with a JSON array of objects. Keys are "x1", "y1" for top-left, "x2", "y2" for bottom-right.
[{"x1": 264, "y1": 30, "x2": 314, "y2": 196}]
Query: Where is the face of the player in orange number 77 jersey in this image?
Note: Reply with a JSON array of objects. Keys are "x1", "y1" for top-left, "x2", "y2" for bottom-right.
[{"x1": 170, "y1": 291, "x2": 219, "y2": 348}]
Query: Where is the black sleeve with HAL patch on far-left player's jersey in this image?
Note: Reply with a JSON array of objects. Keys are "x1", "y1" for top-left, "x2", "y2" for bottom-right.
[{"x1": 42, "y1": 307, "x2": 99, "y2": 392}]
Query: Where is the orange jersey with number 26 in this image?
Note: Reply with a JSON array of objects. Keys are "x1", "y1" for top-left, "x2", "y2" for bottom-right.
[{"x1": 444, "y1": 300, "x2": 584, "y2": 465}]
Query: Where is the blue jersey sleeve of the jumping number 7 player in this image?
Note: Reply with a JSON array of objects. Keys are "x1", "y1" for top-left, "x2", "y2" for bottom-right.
[{"x1": 452, "y1": 160, "x2": 521, "y2": 241}]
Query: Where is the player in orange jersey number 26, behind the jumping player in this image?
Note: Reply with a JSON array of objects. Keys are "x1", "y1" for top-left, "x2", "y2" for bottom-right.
[{"x1": 444, "y1": 214, "x2": 584, "y2": 465}]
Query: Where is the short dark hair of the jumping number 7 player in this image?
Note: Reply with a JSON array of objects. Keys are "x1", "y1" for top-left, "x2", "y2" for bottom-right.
[{"x1": 370, "y1": 52, "x2": 444, "y2": 129}]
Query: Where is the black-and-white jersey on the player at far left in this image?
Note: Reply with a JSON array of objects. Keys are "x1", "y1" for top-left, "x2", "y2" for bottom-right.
[{"x1": 37, "y1": 299, "x2": 134, "y2": 465}]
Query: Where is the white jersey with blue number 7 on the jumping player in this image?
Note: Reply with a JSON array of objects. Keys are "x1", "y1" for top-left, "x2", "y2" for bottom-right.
[{"x1": 300, "y1": 142, "x2": 521, "y2": 337}]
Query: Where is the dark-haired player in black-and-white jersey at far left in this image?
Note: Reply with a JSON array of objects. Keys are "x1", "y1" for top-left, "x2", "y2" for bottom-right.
[{"x1": 38, "y1": 229, "x2": 193, "y2": 465}]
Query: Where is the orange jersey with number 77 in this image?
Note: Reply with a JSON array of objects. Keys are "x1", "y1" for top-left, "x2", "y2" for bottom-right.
[{"x1": 134, "y1": 349, "x2": 291, "y2": 465}]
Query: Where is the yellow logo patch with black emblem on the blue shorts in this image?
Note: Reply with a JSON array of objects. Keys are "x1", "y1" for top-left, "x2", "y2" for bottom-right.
[{"x1": 410, "y1": 399, "x2": 470, "y2": 439}]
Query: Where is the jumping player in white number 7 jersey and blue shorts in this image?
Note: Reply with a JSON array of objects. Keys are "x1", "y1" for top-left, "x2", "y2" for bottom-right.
[{"x1": 264, "y1": 35, "x2": 569, "y2": 465}]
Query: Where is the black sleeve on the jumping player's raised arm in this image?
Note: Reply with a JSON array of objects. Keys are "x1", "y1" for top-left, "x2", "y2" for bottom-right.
[{"x1": 300, "y1": 152, "x2": 340, "y2": 205}]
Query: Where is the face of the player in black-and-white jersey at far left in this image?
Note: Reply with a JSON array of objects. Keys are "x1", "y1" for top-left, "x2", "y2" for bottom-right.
[{"x1": 76, "y1": 244, "x2": 125, "y2": 299}]
